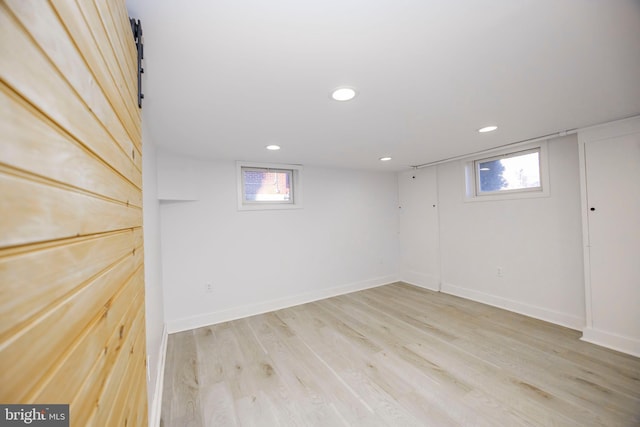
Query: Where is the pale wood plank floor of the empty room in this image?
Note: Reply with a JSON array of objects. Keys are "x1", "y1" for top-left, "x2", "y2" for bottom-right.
[{"x1": 162, "y1": 283, "x2": 640, "y2": 427}]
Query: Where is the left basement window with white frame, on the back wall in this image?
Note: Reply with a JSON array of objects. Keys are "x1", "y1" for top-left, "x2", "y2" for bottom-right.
[{"x1": 237, "y1": 162, "x2": 302, "y2": 210}]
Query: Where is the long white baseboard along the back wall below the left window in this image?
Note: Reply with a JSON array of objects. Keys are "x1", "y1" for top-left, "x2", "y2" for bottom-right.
[{"x1": 167, "y1": 275, "x2": 398, "y2": 334}]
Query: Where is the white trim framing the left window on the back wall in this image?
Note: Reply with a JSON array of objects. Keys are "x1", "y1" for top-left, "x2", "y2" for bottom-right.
[{"x1": 236, "y1": 161, "x2": 303, "y2": 211}]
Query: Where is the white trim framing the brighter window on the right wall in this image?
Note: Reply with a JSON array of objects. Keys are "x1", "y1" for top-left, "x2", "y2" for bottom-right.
[{"x1": 461, "y1": 141, "x2": 550, "y2": 202}]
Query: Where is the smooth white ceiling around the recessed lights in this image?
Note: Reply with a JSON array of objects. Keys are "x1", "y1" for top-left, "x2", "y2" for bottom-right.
[{"x1": 127, "y1": 0, "x2": 640, "y2": 170}]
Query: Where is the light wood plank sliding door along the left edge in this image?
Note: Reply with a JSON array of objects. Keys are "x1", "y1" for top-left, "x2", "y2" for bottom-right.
[{"x1": 0, "y1": 0, "x2": 147, "y2": 426}]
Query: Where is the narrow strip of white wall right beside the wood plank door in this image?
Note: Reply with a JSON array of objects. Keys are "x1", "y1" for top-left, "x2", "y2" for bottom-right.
[{"x1": 142, "y1": 121, "x2": 165, "y2": 420}]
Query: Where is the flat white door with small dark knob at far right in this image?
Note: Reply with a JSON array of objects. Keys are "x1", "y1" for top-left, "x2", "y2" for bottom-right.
[{"x1": 585, "y1": 133, "x2": 640, "y2": 342}]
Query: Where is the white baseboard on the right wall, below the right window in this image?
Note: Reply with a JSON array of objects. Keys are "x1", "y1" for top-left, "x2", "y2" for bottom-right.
[{"x1": 441, "y1": 283, "x2": 585, "y2": 331}]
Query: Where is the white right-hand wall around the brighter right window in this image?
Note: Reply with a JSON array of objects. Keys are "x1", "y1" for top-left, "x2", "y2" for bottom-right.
[{"x1": 399, "y1": 135, "x2": 585, "y2": 329}]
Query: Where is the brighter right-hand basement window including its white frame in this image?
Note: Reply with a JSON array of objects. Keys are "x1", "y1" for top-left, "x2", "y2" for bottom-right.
[{"x1": 466, "y1": 142, "x2": 549, "y2": 201}]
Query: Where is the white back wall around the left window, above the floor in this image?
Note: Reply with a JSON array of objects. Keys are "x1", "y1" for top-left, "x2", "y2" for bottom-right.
[{"x1": 158, "y1": 152, "x2": 399, "y2": 332}]
